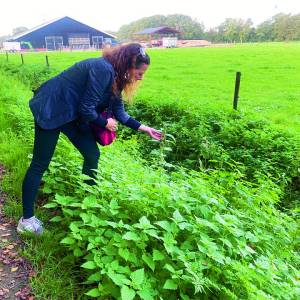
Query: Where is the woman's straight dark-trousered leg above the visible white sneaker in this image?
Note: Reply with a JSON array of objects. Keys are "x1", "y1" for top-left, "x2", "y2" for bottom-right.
[{"x1": 22, "y1": 124, "x2": 60, "y2": 219}]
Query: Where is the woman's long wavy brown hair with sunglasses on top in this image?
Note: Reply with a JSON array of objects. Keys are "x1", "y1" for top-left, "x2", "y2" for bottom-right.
[{"x1": 103, "y1": 43, "x2": 150, "y2": 101}]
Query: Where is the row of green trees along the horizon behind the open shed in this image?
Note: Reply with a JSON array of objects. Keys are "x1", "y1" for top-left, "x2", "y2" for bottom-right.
[{"x1": 114, "y1": 13, "x2": 300, "y2": 43}]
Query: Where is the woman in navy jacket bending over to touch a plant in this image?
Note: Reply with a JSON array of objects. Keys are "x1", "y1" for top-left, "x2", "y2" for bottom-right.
[{"x1": 17, "y1": 43, "x2": 161, "y2": 234}]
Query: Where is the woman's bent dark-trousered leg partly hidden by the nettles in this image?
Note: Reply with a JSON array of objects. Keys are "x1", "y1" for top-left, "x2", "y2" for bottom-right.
[{"x1": 61, "y1": 122, "x2": 100, "y2": 185}]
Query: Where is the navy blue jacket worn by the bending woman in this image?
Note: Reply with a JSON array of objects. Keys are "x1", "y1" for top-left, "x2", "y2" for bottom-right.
[{"x1": 29, "y1": 58, "x2": 138, "y2": 129}]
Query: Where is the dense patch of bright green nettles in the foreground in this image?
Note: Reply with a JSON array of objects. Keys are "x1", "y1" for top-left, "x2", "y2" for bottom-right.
[{"x1": 45, "y1": 141, "x2": 300, "y2": 300}]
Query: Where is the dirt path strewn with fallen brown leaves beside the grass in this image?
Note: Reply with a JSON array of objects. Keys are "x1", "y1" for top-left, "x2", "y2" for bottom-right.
[{"x1": 0, "y1": 165, "x2": 34, "y2": 300}]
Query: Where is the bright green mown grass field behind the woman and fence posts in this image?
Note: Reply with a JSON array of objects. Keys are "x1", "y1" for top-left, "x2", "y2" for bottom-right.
[{"x1": 0, "y1": 43, "x2": 300, "y2": 134}]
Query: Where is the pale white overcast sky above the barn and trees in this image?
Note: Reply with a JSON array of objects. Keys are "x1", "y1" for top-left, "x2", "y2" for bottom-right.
[{"x1": 0, "y1": 0, "x2": 300, "y2": 36}]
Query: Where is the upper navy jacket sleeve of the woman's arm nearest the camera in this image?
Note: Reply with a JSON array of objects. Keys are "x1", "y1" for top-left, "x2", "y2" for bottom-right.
[{"x1": 78, "y1": 67, "x2": 113, "y2": 122}]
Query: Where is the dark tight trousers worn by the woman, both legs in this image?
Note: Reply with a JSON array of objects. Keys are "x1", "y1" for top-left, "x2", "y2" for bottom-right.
[{"x1": 22, "y1": 121, "x2": 100, "y2": 219}]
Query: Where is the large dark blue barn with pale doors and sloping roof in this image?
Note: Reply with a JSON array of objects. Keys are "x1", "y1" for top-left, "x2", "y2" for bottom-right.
[{"x1": 8, "y1": 16, "x2": 116, "y2": 50}]
